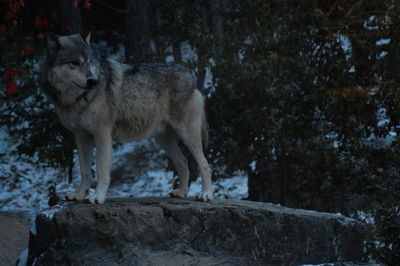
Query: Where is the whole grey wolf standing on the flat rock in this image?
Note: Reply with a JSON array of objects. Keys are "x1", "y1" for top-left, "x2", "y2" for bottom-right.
[{"x1": 41, "y1": 34, "x2": 213, "y2": 204}]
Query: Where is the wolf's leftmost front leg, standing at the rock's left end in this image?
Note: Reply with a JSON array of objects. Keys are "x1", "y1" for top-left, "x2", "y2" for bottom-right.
[{"x1": 67, "y1": 133, "x2": 94, "y2": 201}]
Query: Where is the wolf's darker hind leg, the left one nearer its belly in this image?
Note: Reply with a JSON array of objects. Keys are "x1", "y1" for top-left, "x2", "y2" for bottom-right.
[{"x1": 156, "y1": 128, "x2": 189, "y2": 198}]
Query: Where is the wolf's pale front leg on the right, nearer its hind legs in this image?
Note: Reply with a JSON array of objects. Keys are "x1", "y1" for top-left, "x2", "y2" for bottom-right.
[{"x1": 88, "y1": 128, "x2": 112, "y2": 204}]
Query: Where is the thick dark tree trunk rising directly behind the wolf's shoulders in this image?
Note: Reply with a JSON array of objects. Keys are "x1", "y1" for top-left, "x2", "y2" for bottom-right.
[{"x1": 125, "y1": 0, "x2": 150, "y2": 63}]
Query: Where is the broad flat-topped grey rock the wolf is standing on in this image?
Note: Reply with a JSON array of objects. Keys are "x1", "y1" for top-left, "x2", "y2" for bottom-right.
[{"x1": 28, "y1": 198, "x2": 365, "y2": 266}]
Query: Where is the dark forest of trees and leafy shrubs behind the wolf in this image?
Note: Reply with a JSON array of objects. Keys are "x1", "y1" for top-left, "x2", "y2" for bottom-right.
[{"x1": 0, "y1": 0, "x2": 400, "y2": 265}]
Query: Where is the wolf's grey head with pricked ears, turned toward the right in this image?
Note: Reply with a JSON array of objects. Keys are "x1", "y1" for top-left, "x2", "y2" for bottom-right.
[{"x1": 46, "y1": 34, "x2": 100, "y2": 103}]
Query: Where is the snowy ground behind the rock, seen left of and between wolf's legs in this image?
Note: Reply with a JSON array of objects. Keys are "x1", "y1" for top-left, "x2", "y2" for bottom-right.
[{"x1": 0, "y1": 128, "x2": 248, "y2": 212}]
